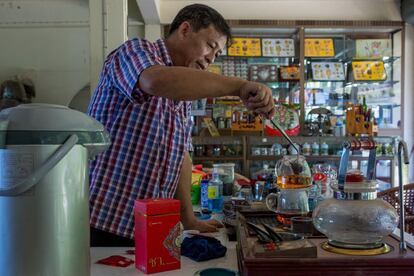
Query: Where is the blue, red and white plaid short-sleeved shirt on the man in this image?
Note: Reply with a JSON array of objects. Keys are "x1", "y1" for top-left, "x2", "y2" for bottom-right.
[{"x1": 88, "y1": 39, "x2": 192, "y2": 238}]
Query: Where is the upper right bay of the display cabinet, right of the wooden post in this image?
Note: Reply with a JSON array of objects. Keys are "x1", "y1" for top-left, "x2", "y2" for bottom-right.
[{"x1": 303, "y1": 22, "x2": 404, "y2": 135}]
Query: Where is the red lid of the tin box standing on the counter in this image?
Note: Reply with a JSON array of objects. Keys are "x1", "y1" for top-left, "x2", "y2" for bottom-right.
[{"x1": 135, "y1": 198, "x2": 180, "y2": 216}]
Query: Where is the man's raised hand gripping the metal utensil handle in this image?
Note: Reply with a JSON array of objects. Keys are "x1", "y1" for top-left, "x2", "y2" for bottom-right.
[{"x1": 240, "y1": 81, "x2": 275, "y2": 119}]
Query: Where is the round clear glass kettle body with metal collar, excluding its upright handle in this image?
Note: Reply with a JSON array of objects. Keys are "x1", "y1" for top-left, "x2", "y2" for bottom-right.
[{"x1": 313, "y1": 180, "x2": 398, "y2": 249}]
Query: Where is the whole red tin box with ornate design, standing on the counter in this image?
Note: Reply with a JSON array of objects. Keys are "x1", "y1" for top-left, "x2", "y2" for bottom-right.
[{"x1": 135, "y1": 199, "x2": 180, "y2": 273}]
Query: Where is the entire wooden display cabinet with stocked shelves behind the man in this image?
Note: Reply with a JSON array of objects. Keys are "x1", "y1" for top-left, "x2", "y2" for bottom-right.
[{"x1": 189, "y1": 20, "x2": 404, "y2": 189}]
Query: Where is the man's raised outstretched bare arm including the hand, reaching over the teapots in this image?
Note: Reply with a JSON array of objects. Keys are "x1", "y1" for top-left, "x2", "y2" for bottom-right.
[{"x1": 138, "y1": 65, "x2": 274, "y2": 118}]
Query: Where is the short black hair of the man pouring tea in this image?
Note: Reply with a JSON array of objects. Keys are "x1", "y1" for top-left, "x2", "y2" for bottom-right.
[{"x1": 168, "y1": 4, "x2": 231, "y2": 44}]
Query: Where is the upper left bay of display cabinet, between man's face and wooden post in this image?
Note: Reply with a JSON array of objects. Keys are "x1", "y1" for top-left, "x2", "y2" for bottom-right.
[{"x1": 213, "y1": 27, "x2": 300, "y2": 103}]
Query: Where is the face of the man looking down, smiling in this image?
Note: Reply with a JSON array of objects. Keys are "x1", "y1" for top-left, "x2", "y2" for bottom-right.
[{"x1": 182, "y1": 25, "x2": 227, "y2": 70}]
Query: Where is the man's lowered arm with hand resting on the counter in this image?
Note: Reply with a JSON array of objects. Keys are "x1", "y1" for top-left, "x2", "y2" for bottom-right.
[{"x1": 175, "y1": 152, "x2": 222, "y2": 232}]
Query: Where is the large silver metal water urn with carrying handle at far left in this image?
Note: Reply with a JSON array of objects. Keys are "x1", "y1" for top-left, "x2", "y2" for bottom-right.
[{"x1": 0, "y1": 104, "x2": 109, "y2": 276}]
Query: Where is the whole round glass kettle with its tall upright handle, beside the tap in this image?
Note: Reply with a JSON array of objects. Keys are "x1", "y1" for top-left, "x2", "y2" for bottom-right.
[{"x1": 312, "y1": 140, "x2": 398, "y2": 249}]
